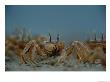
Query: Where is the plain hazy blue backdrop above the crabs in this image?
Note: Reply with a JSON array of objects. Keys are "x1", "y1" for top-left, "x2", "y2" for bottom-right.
[{"x1": 5, "y1": 5, "x2": 106, "y2": 42}]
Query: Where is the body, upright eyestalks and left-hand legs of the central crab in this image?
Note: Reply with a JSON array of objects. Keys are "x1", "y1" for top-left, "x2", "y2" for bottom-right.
[{"x1": 20, "y1": 34, "x2": 64, "y2": 64}]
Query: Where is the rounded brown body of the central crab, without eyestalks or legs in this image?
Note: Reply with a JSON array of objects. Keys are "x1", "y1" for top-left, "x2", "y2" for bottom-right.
[{"x1": 39, "y1": 42, "x2": 64, "y2": 56}]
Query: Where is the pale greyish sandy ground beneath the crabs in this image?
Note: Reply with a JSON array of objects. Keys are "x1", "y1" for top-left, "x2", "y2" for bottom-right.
[{"x1": 5, "y1": 52, "x2": 106, "y2": 71}]
